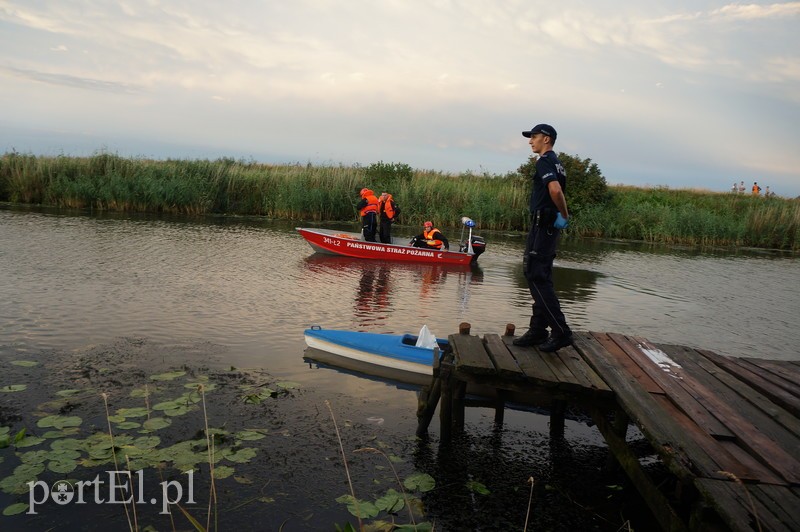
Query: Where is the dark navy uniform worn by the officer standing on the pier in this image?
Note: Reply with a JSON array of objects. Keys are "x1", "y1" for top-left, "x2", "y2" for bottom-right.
[{"x1": 523, "y1": 151, "x2": 572, "y2": 338}]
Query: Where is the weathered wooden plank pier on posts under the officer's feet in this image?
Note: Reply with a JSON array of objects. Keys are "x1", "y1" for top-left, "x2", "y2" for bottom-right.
[{"x1": 417, "y1": 323, "x2": 800, "y2": 531}]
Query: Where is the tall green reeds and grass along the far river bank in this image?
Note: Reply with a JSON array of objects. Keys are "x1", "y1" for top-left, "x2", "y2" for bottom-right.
[{"x1": 0, "y1": 153, "x2": 800, "y2": 251}]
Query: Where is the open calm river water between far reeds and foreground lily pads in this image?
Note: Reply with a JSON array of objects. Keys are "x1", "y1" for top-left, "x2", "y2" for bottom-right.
[{"x1": 0, "y1": 209, "x2": 800, "y2": 368}]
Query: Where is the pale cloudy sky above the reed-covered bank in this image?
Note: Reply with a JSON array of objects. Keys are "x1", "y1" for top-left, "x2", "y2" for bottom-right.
[{"x1": 0, "y1": 0, "x2": 800, "y2": 196}]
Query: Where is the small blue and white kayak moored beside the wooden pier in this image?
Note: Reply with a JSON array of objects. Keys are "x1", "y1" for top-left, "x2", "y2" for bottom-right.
[{"x1": 303, "y1": 326, "x2": 448, "y2": 377}]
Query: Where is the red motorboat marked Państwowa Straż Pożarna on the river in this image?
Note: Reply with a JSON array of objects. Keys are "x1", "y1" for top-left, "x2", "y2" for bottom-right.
[{"x1": 296, "y1": 217, "x2": 486, "y2": 264}]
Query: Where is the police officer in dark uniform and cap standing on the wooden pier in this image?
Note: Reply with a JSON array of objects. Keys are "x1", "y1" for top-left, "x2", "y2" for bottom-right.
[{"x1": 514, "y1": 124, "x2": 572, "y2": 352}]
